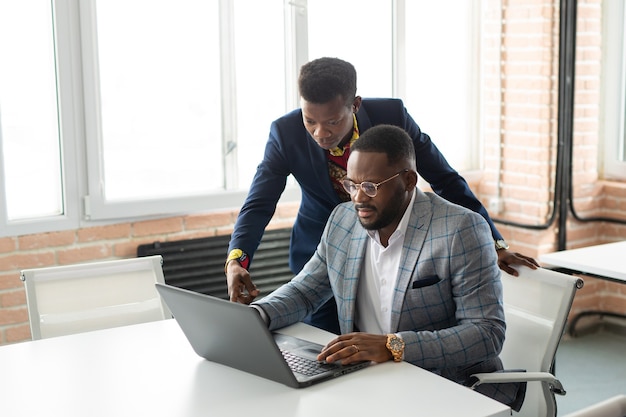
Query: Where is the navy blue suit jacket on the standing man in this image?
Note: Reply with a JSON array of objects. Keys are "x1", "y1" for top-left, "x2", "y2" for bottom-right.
[{"x1": 228, "y1": 99, "x2": 502, "y2": 274}]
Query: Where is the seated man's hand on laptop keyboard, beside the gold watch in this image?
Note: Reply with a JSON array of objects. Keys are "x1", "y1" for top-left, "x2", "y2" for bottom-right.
[{"x1": 317, "y1": 333, "x2": 393, "y2": 365}]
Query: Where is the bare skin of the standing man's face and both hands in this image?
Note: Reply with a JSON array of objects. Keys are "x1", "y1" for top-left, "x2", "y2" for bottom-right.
[{"x1": 226, "y1": 96, "x2": 539, "y2": 304}]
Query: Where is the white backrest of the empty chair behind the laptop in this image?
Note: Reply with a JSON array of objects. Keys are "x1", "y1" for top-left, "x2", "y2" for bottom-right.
[{"x1": 21, "y1": 255, "x2": 171, "y2": 340}]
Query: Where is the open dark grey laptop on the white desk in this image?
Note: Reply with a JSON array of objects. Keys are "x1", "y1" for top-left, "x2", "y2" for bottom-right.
[{"x1": 155, "y1": 283, "x2": 370, "y2": 388}]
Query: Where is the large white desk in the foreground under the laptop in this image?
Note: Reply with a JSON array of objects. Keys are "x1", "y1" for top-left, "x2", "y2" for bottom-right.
[{"x1": 0, "y1": 320, "x2": 510, "y2": 417}]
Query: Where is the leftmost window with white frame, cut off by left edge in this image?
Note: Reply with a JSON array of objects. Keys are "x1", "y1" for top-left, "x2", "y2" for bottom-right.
[{"x1": 0, "y1": 0, "x2": 82, "y2": 236}]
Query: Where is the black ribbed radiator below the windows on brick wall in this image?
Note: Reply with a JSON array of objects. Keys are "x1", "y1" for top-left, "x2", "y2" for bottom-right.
[{"x1": 137, "y1": 228, "x2": 293, "y2": 299}]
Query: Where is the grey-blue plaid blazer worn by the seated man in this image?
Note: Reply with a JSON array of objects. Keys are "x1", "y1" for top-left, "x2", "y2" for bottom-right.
[{"x1": 255, "y1": 189, "x2": 505, "y2": 384}]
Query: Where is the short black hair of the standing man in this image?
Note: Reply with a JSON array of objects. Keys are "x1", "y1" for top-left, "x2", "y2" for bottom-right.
[{"x1": 298, "y1": 57, "x2": 356, "y2": 105}]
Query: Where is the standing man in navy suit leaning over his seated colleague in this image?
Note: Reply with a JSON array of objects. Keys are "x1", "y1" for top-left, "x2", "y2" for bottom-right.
[{"x1": 225, "y1": 58, "x2": 537, "y2": 333}]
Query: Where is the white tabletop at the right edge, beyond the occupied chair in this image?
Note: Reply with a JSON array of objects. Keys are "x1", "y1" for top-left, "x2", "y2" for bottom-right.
[{"x1": 539, "y1": 241, "x2": 626, "y2": 282}]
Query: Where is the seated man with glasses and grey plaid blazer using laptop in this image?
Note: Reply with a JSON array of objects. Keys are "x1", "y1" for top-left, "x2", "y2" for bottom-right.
[{"x1": 252, "y1": 125, "x2": 517, "y2": 403}]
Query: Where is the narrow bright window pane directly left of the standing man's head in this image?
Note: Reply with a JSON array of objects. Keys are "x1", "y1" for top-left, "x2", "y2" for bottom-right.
[{"x1": 232, "y1": 0, "x2": 286, "y2": 190}]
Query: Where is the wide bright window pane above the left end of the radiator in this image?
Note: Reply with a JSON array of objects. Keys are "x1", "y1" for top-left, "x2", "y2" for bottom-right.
[{"x1": 90, "y1": 0, "x2": 224, "y2": 202}]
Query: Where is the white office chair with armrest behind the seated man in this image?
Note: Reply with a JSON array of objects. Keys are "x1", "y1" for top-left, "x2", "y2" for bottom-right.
[{"x1": 472, "y1": 267, "x2": 583, "y2": 417}]
